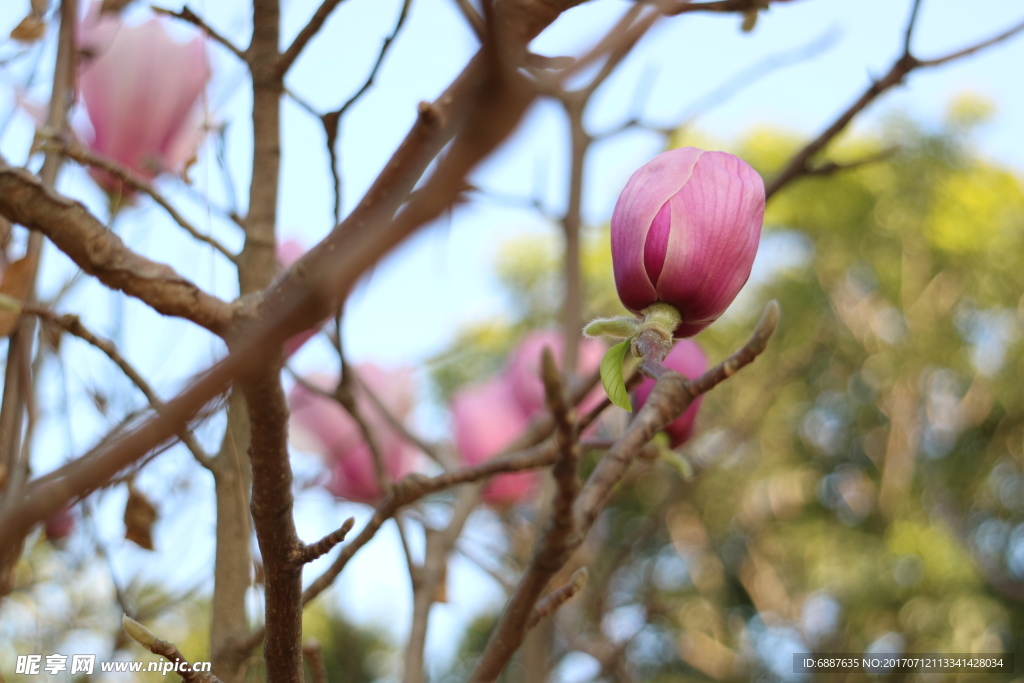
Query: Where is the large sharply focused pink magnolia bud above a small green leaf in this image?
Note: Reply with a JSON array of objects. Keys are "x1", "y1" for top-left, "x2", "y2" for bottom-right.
[{"x1": 611, "y1": 147, "x2": 765, "y2": 337}]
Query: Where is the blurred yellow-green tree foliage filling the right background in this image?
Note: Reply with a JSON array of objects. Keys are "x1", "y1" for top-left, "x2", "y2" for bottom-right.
[{"x1": 435, "y1": 98, "x2": 1024, "y2": 682}]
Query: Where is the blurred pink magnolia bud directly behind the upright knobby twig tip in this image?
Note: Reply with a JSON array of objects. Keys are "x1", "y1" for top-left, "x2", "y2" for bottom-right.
[{"x1": 506, "y1": 330, "x2": 605, "y2": 418}]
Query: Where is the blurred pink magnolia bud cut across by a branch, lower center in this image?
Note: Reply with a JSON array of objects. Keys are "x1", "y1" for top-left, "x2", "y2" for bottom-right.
[{"x1": 452, "y1": 375, "x2": 540, "y2": 507}]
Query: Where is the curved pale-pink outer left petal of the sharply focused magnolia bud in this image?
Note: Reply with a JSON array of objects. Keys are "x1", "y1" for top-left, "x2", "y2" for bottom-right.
[{"x1": 611, "y1": 147, "x2": 703, "y2": 312}]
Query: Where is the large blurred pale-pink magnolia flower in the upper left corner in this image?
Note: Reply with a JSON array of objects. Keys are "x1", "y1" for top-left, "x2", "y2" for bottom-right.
[{"x1": 79, "y1": 2, "x2": 210, "y2": 191}]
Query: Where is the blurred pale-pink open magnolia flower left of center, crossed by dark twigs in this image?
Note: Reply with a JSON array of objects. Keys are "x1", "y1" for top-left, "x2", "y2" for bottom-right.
[{"x1": 289, "y1": 365, "x2": 416, "y2": 505}]
